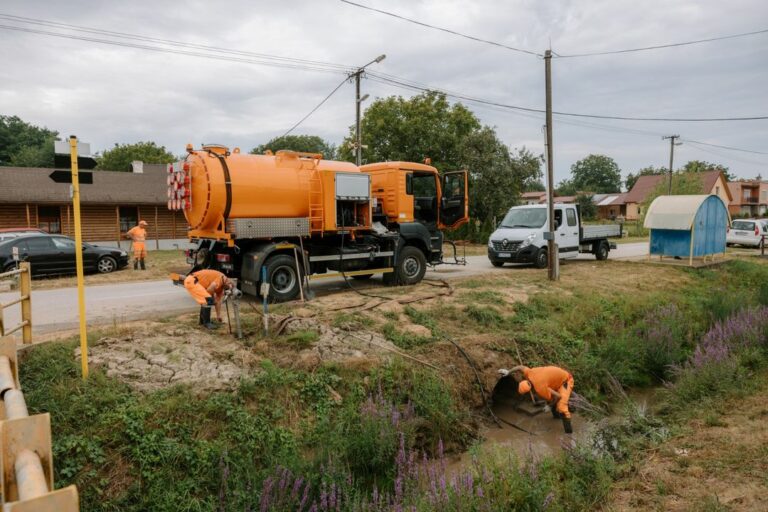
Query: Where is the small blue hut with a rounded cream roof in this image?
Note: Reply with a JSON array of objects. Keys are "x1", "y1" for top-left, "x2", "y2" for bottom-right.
[{"x1": 644, "y1": 195, "x2": 730, "y2": 264}]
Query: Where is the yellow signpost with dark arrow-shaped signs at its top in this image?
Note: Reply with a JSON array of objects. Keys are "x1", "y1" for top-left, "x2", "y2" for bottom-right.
[{"x1": 50, "y1": 135, "x2": 96, "y2": 380}]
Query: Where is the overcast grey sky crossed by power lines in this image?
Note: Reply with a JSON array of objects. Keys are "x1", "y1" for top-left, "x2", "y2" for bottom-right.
[{"x1": 0, "y1": 0, "x2": 768, "y2": 186}]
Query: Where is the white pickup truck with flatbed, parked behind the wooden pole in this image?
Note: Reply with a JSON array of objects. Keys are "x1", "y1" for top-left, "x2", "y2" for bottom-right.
[{"x1": 488, "y1": 204, "x2": 622, "y2": 268}]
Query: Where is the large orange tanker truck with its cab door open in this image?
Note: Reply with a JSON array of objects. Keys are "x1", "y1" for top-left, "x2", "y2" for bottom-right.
[{"x1": 168, "y1": 145, "x2": 469, "y2": 301}]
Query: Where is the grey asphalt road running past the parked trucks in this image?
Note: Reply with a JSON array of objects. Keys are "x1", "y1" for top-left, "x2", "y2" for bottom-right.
[{"x1": 0, "y1": 243, "x2": 648, "y2": 335}]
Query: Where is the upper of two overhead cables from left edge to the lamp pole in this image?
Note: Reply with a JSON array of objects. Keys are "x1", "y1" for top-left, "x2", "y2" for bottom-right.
[{"x1": 0, "y1": 13, "x2": 350, "y2": 72}]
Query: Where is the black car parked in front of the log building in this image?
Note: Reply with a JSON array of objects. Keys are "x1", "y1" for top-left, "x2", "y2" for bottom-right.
[{"x1": 0, "y1": 234, "x2": 128, "y2": 276}]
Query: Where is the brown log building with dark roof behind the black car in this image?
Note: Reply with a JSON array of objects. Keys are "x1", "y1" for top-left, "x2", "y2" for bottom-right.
[{"x1": 0, "y1": 162, "x2": 187, "y2": 250}]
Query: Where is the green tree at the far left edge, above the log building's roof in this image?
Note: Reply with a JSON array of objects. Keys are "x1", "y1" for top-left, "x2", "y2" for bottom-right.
[{"x1": 0, "y1": 116, "x2": 59, "y2": 167}]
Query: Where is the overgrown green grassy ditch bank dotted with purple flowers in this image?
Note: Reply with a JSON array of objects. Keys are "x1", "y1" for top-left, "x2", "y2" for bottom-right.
[{"x1": 21, "y1": 261, "x2": 768, "y2": 511}]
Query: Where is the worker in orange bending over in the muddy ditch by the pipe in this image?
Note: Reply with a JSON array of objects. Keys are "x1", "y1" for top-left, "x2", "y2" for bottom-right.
[{"x1": 499, "y1": 366, "x2": 573, "y2": 434}]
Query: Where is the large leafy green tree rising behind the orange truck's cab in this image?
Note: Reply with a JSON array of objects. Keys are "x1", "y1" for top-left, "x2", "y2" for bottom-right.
[{"x1": 339, "y1": 92, "x2": 541, "y2": 226}]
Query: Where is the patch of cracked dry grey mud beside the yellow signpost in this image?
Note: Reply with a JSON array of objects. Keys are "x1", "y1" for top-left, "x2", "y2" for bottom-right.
[{"x1": 80, "y1": 326, "x2": 256, "y2": 391}]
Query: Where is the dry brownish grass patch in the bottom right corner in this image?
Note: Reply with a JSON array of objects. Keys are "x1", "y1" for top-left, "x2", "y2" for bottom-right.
[{"x1": 603, "y1": 388, "x2": 768, "y2": 512}]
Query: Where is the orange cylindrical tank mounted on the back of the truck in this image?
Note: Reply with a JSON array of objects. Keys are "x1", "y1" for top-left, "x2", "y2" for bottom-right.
[{"x1": 174, "y1": 146, "x2": 360, "y2": 238}]
